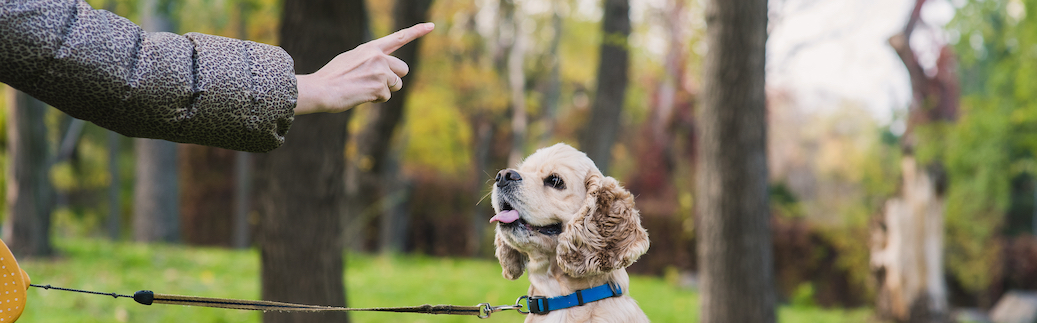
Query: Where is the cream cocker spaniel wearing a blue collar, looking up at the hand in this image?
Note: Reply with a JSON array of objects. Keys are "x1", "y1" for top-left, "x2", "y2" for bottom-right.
[{"x1": 489, "y1": 143, "x2": 648, "y2": 322}]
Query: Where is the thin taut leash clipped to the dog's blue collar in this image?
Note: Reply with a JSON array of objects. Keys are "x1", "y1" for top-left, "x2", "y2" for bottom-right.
[{"x1": 29, "y1": 284, "x2": 528, "y2": 319}]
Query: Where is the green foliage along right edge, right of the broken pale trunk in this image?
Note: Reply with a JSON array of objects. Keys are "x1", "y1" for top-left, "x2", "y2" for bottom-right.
[{"x1": 945, "y1": 0, "x2": 1037, "y2": 292}]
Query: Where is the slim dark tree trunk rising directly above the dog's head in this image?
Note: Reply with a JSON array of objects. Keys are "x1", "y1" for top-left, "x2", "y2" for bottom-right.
[{"x1": 580, "y1": 0, "x2": 630, "y2": 173}]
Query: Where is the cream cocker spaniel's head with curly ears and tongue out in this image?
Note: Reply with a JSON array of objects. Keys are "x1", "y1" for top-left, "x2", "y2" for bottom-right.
[{"x1": 491, "y1": 143, "x2": 648, "y2": 279}]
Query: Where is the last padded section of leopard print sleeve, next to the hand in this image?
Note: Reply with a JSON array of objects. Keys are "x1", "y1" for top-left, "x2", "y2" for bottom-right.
[{"x1": 181, "y1": 33, "x2": 298, "y2": 152}]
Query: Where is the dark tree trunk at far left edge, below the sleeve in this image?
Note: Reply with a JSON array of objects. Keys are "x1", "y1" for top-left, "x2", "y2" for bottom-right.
[{"x1": 3, "y1": 87, "x2": 55, "y2": 258}]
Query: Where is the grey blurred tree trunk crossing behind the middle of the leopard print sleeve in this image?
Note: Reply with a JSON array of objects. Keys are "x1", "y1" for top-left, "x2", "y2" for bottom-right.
[{"x1": 133, "y1": 0, "x2": 180, "y2": 242}]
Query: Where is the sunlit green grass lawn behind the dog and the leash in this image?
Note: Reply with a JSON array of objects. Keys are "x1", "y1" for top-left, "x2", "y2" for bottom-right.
[{"x1": 20, "y1": 239, "x2": 870, "y2": 322}]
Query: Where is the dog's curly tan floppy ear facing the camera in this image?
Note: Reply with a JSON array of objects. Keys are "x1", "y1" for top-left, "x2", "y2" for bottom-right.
[{"x1": 558, "y1": 173, "x2": 648, "y2": 277}]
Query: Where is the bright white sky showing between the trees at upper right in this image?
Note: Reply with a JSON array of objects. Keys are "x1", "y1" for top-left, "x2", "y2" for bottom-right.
[{"x1": 767, "y1": 0, "x2": 954, "y2": 128}]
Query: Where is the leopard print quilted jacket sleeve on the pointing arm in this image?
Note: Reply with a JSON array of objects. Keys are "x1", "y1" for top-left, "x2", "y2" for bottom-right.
[{"x1": 0, "y1": 0, "x2": 298, "y2": 152}]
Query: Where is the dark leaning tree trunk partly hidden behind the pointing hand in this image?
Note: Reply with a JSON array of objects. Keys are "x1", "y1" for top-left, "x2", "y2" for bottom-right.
[{"x1": 346, "y1": 0, "x2": 432, "y2": 253}]
